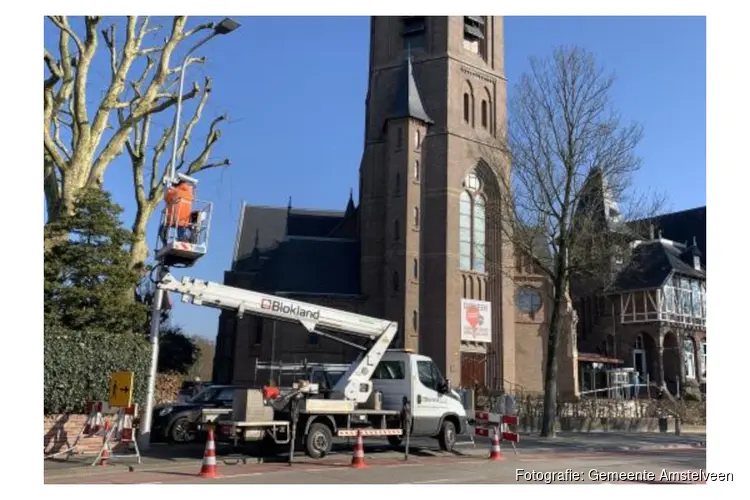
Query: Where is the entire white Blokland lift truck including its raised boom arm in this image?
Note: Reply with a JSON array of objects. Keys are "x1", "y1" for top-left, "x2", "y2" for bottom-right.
[{"x1": 157, "y1": 274, "x2": 468, "y2": 458}]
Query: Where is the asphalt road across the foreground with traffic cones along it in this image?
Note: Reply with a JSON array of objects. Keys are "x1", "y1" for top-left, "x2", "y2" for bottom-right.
[{"x1": 45, "y1": 448, "x2": 712, "y2": 485}]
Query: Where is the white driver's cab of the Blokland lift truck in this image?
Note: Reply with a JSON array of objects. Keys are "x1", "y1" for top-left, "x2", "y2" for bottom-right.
[{"x1": 372, "y1": 349, "x2": 468, "y2": 451}]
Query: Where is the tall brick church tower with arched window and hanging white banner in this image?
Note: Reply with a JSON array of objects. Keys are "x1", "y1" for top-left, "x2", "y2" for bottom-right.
[{"x1": 359, "y1": 16, "x2": 516, "y2": 386}]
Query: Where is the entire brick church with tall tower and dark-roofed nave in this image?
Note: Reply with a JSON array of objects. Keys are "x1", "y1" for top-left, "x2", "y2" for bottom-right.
[{"x1": 215, "y1": 16, "x2": 575, "y2": 391}]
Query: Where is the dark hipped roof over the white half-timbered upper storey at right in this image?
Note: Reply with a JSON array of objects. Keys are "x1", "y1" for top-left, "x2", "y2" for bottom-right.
[{"x1": 606, "y1": 239, "x2": 706, "y2": 293}]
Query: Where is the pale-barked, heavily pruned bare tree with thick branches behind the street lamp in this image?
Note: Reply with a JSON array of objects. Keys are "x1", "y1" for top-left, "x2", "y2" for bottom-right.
[{"x1": 44, "y1": 16, "x2": 228, "y2": 262}]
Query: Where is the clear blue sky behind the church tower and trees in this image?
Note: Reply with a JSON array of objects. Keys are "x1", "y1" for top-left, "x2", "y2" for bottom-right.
[{"x1": 45, "y1": 17, "x2": 706, "y2": 338}]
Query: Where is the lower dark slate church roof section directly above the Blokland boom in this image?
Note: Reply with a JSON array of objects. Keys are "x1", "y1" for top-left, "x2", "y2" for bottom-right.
[{"x1": 253, "y1": 238, "x2": 360, "y2": 295}]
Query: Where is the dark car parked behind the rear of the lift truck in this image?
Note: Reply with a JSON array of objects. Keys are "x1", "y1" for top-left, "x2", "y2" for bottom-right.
[{"x1": 151, "y1": 385, "x2": 238, "y2": 443}]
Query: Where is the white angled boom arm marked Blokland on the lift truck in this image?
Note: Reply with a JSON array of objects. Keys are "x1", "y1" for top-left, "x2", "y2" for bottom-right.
[{"x1": 156, "y1": 274, "x2": 398, "y2": 403}]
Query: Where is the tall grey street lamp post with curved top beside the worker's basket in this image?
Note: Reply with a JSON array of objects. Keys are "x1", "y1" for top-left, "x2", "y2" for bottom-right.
[{"x1": 138, "y1": 18, "x2": 240, "y2": 450}]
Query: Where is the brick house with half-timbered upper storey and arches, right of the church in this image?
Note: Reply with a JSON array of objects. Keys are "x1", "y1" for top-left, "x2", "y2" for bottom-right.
[{"x1": 576, "y1": 206, "x2": 706, "y2": 395}]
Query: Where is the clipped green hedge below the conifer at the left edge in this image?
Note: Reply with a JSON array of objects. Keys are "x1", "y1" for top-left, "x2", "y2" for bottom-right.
[{"x1": 44, "y1": 328, "x2": 151, "y2": 415}]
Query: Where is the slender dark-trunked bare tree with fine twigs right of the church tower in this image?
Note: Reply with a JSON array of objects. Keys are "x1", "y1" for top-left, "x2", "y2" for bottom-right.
[{"x1": 482, "y1": 47, "x2": 661, "y2": 437}]
